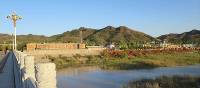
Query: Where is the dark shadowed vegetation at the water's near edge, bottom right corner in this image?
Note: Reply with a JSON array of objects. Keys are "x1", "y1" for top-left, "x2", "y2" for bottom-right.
[{"x1": 123, "y1": 76, "x2": 200, "y2": 88}]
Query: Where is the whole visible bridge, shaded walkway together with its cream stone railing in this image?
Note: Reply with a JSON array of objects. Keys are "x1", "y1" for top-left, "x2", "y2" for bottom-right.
[{"x1": 0, "y1": 51, "x2": 56, "y2": 88}]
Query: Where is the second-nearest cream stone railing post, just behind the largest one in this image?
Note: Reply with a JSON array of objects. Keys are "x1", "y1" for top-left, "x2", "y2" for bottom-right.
[{"x1": 24, "y1": 56, "x2": 35, "y2": 80}]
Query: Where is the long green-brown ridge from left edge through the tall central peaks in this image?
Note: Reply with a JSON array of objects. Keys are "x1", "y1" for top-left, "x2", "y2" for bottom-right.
[{"x1": 0, "y1": 26, "x2": 156, "y2": 47}]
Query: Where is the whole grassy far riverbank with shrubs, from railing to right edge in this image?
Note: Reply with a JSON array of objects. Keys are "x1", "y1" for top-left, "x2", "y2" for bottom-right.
[{"x1": 47, "y1": 51, "x2": 200, "y2": 70}]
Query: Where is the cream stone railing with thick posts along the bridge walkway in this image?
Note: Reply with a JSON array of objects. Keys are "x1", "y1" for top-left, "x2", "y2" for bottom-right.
[{"x1": 14, "y1": 51, "x2": 56, "y2": 88}]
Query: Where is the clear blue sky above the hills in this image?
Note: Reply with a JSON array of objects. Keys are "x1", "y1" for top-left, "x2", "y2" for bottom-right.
[{"x1": 0, "y1": 0, "x2": 200, "y2": 37}]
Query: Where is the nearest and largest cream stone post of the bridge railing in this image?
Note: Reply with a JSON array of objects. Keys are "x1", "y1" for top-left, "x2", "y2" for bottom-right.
[{"x1": 35, "y1": 63, "x2": 56, "y2": 88}]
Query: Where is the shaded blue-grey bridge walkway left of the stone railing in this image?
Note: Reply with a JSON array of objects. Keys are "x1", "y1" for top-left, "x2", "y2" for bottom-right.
[{"x1": 0, "y1": 54, "x2": 15, "y2": 88}]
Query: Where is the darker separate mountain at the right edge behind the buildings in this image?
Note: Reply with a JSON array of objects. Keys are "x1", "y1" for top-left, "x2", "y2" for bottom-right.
[{"x1": 158, "y1": 29, "x2": 200, "y2": 44}]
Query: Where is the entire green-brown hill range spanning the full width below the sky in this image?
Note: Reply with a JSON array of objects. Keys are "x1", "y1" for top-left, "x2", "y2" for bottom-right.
[{"x1": 0, "y1": 26, "x2": 200, "y2": 50}]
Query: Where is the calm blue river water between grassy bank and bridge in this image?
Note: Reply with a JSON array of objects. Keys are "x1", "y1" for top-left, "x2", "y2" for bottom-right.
[{"x1": 57, "y1": 65, "x2": 200, "y2": 88}]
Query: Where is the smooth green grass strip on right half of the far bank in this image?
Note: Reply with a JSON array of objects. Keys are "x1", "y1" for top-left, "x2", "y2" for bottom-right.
[{"x1": 103, "y1": 52, "x2": 200, "y2": 69}]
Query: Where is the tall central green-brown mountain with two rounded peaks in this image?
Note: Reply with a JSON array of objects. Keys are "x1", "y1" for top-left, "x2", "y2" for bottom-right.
[{"x1": 84, "y1": 26, "x2": 156, "y2": 45}]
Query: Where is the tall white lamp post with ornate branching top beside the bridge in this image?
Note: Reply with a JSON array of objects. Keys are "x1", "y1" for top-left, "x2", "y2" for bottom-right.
[{"x1": 7, "y1": 12, "x2": 22, "y2": 50}]
